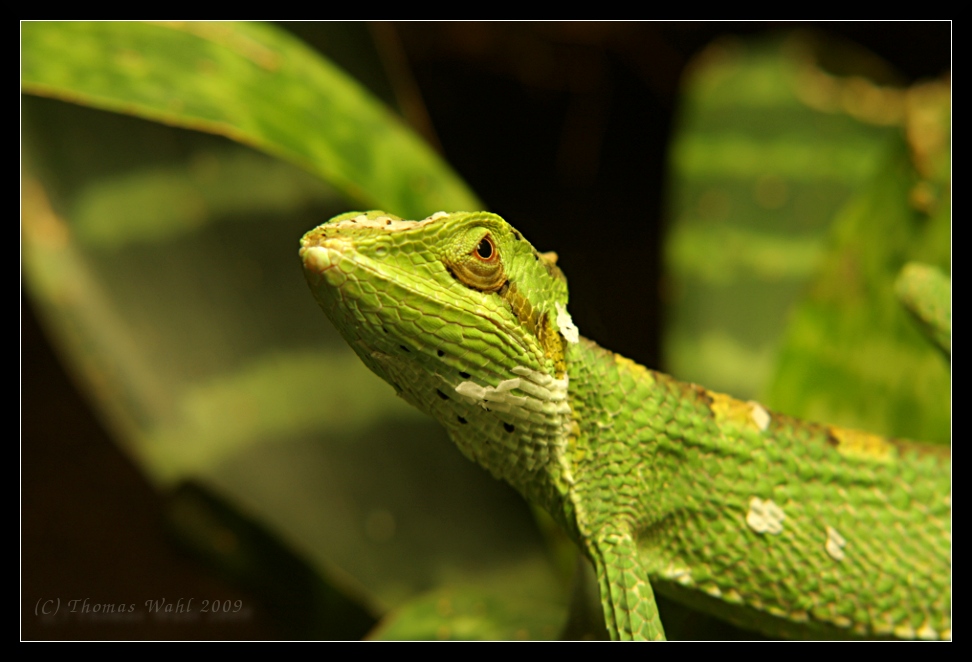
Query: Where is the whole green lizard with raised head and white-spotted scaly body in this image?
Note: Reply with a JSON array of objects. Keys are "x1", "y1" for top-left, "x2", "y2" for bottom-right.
[{"x1": 300, "y1": 211, "x2": 951, "y2": 639}]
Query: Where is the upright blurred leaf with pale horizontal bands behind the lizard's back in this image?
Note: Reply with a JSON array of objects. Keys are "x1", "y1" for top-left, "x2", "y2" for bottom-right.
[{"x1": 665, "y1": 33, "x2": 901, "y2": 398}]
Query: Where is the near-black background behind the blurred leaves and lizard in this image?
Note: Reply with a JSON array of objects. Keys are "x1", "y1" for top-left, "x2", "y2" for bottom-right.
[{"x1": 20, "y1": 22, "x2": 951, "y2": 639}]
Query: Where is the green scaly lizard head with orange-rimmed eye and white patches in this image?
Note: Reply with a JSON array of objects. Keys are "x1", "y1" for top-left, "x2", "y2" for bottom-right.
[{"x1": 300, "y1": 211, "x2": 577, "y2": 496}]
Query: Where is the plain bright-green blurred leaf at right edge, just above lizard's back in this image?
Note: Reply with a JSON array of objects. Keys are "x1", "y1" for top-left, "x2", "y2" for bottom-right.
[{"x1": 765, "y1": 98, "x2": 951, "y2": 444}]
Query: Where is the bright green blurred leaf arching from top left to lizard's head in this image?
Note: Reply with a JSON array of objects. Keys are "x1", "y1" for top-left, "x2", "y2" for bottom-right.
[{"x1": 21, "y1": 22, "x2": 481, "y2": 218}]
